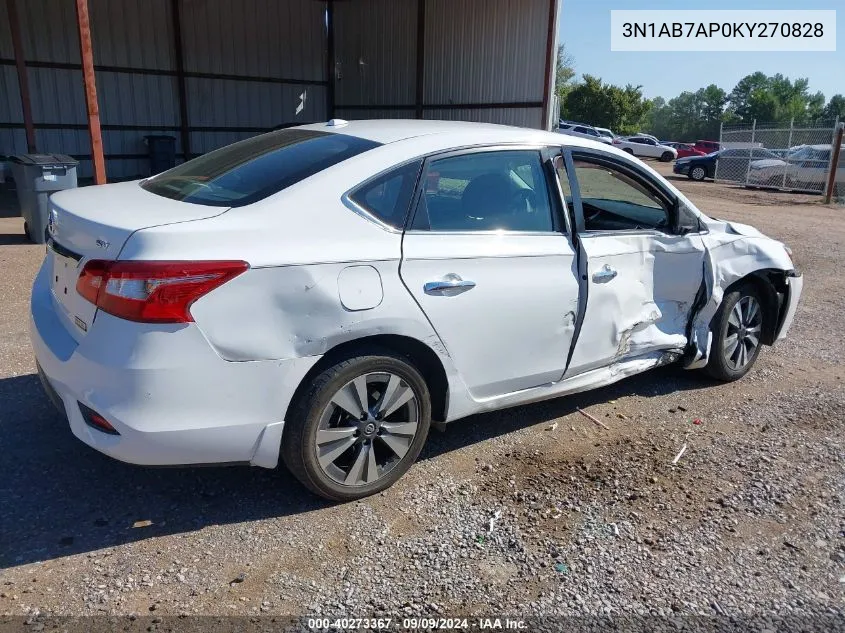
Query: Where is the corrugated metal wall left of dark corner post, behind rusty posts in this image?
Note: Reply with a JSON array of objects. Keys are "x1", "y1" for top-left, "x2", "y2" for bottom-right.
[{"x1": 0, "y1": 0, "x2": 327, "y2": 180}]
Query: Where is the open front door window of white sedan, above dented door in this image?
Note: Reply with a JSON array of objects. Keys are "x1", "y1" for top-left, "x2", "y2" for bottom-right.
[{"x1": 575, "y1": 159, "x2": 670, "y2": 231}]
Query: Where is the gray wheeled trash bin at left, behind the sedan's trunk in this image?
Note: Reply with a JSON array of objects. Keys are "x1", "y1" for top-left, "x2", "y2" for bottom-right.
[{"x1": 11, "y1": 154, "x2": 79, "y2": 244}]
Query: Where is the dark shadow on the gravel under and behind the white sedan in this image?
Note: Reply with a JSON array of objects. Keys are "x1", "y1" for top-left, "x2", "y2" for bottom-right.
[{"x1": 0, "y1": 368, "x2": 713, "y2": 569}]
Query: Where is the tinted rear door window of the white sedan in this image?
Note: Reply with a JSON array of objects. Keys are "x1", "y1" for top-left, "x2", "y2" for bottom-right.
[{"x1": 411, "y1": 150, "x2": 554, "y2": 232}]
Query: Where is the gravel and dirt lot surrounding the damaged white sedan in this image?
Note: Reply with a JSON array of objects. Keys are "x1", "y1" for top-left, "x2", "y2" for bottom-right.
[{"x1": 0, "y1": 165, "x2": 845, "y2": 621}]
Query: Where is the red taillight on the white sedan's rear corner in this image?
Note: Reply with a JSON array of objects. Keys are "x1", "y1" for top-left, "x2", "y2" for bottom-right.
[{"x1": 76, "y1": 259, "x2": 249, "y2": 323}]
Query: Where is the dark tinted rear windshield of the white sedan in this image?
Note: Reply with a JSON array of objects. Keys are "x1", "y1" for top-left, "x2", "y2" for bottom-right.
[{"x1": 141, "y1": 130, "x2": 380, "y2": 207}]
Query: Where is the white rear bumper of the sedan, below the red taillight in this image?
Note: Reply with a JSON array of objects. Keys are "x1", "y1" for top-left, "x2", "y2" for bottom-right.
[{"x1": 30, "y1": 260, "x2": 319, "y2": 468}]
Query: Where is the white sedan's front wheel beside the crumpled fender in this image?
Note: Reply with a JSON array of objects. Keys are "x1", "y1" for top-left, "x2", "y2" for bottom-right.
[{"x1": 705, "y1": 284, "x2": 765, "y2": 382}]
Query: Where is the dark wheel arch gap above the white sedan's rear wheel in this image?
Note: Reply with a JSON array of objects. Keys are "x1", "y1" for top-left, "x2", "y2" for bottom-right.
[{"x1": 284, "y1": 334, "x2": 449, "y2": 421}]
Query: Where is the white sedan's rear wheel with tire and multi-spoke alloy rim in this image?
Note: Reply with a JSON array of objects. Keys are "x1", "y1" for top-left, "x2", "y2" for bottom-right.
[{"x1": 282, "y1": 350, "x2": 431, "y2": 501}]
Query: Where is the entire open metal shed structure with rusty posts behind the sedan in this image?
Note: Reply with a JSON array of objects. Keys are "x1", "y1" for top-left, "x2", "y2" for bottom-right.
[{"x1": 0, "y1": 0, "x2": 559, "y2": 180}]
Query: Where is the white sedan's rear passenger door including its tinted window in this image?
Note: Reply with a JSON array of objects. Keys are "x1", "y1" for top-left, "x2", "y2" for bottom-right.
[{"x1": 400, "y1": 147, "x2": 579, "y2": 399}]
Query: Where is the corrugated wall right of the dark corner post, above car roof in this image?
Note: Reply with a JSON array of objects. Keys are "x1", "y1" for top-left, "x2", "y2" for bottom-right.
[{"x1": 335, "y1": 0, "x2": 550, "y2": 127}]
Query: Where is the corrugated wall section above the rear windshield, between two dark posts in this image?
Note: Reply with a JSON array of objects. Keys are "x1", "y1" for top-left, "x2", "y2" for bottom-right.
[{"x1": 182, "y1": 0, "x2": 327, "y2": 153}]
